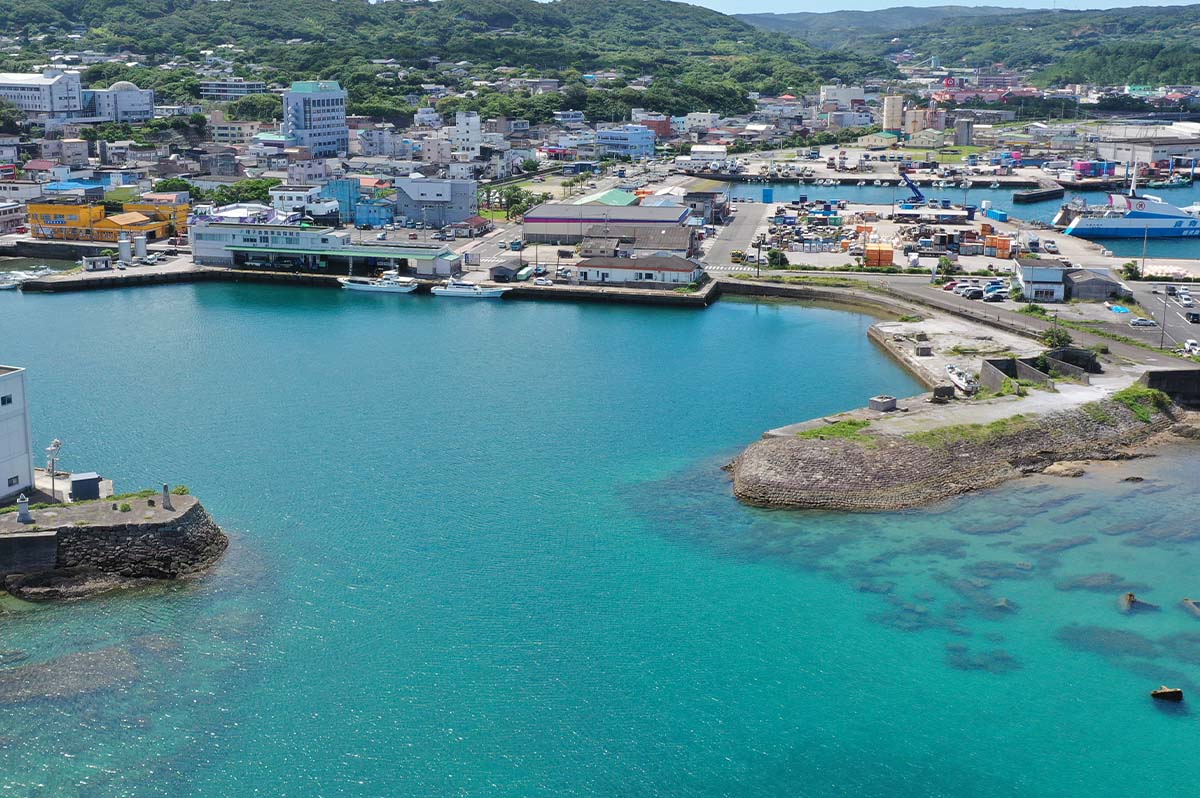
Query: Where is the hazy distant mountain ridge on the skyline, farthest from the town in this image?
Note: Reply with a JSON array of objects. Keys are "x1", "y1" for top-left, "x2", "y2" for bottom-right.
[{"x1": 733, "y1": 6, "x2": 1033, "y2": 49}]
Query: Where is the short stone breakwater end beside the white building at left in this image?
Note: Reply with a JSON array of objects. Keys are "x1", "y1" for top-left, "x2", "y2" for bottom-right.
[{"x1": 0, "y1": 496, "x2": 229, "y2": 600}]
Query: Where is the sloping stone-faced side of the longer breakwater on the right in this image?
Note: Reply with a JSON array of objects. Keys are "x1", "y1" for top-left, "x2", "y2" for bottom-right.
[{"x1": 728, "y1": 401, "x2": 1180, "y2": 511}]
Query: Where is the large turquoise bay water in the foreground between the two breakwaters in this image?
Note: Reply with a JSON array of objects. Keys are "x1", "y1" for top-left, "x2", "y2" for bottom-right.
[{"x1": 0, "y1": 284, "x2": 1200, "y2": 798}]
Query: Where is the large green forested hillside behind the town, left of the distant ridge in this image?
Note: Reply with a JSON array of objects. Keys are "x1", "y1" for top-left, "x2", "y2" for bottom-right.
[{"x1": 0, "y1": 0, "x2": 892, "y2": 115}]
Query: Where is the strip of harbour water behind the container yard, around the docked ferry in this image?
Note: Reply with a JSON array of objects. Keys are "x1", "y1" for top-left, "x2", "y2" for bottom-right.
[{"x1": 731, "y1": 178, "x2": 1200, "y2": 258}]
